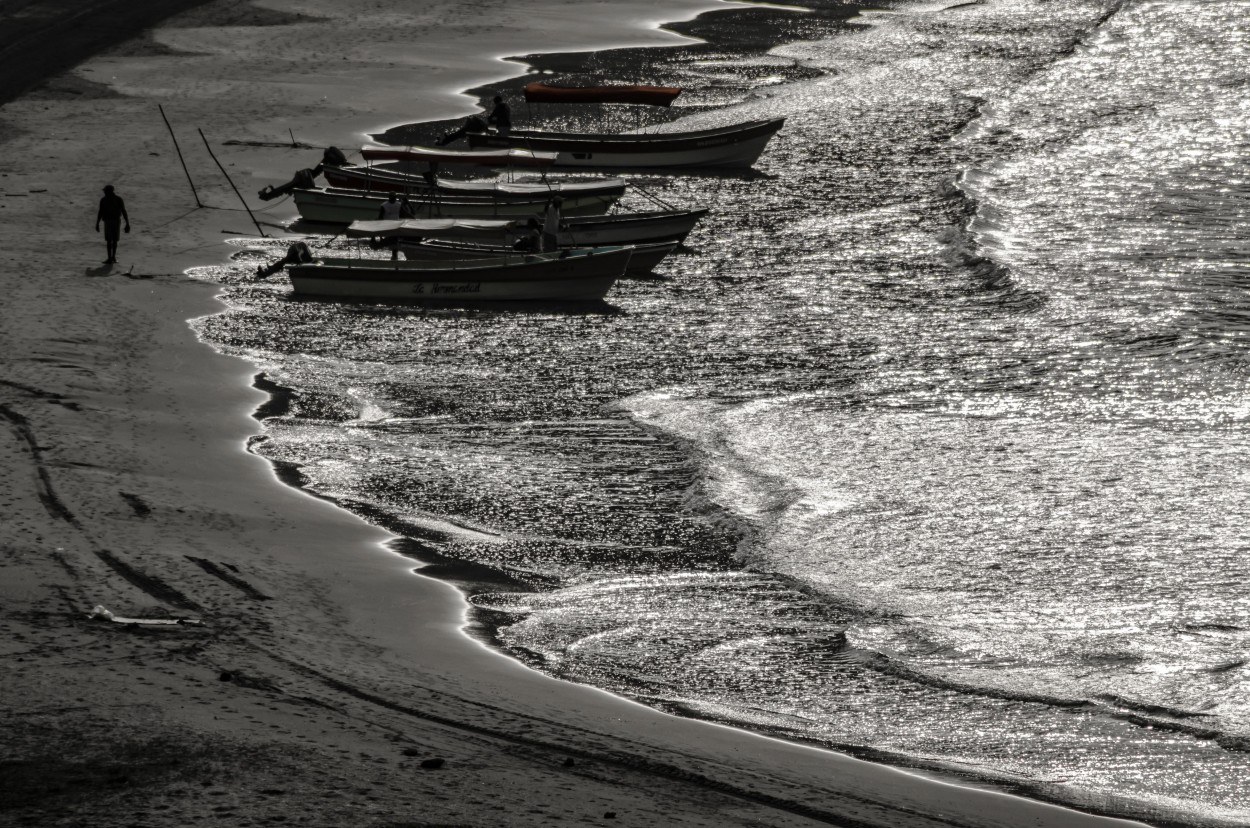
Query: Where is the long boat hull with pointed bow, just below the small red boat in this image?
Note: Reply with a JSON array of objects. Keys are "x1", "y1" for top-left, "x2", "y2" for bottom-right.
[{"x1": 468, "y1": 118, "x2": 785, "y2": 169}]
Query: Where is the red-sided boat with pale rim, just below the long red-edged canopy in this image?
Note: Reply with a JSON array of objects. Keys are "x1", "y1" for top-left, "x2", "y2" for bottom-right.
[{"x1": 321, "y1": 165, "x2": 626, "y2": 200}]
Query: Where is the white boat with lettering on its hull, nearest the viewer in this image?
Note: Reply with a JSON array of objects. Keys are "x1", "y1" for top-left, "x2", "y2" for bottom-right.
[{"x1": 286, "y1": 248, "x2": 633, "y2": 304}]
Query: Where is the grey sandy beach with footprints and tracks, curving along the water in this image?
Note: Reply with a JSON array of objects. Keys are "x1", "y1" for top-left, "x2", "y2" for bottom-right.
[{"x1": 0, "y1": 0, "x2": 1160, "y2": 827}]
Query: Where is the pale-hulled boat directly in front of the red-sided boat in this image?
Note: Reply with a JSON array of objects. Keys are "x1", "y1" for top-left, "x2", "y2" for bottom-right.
[{"x1": 291, "y1": 188, "x2": 619, "y2": 224}]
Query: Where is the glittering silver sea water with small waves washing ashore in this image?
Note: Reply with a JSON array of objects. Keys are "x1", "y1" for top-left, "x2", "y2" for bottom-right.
[{"x1": 190, "y1": 0, "x2": 1250, "y2": 825}]
